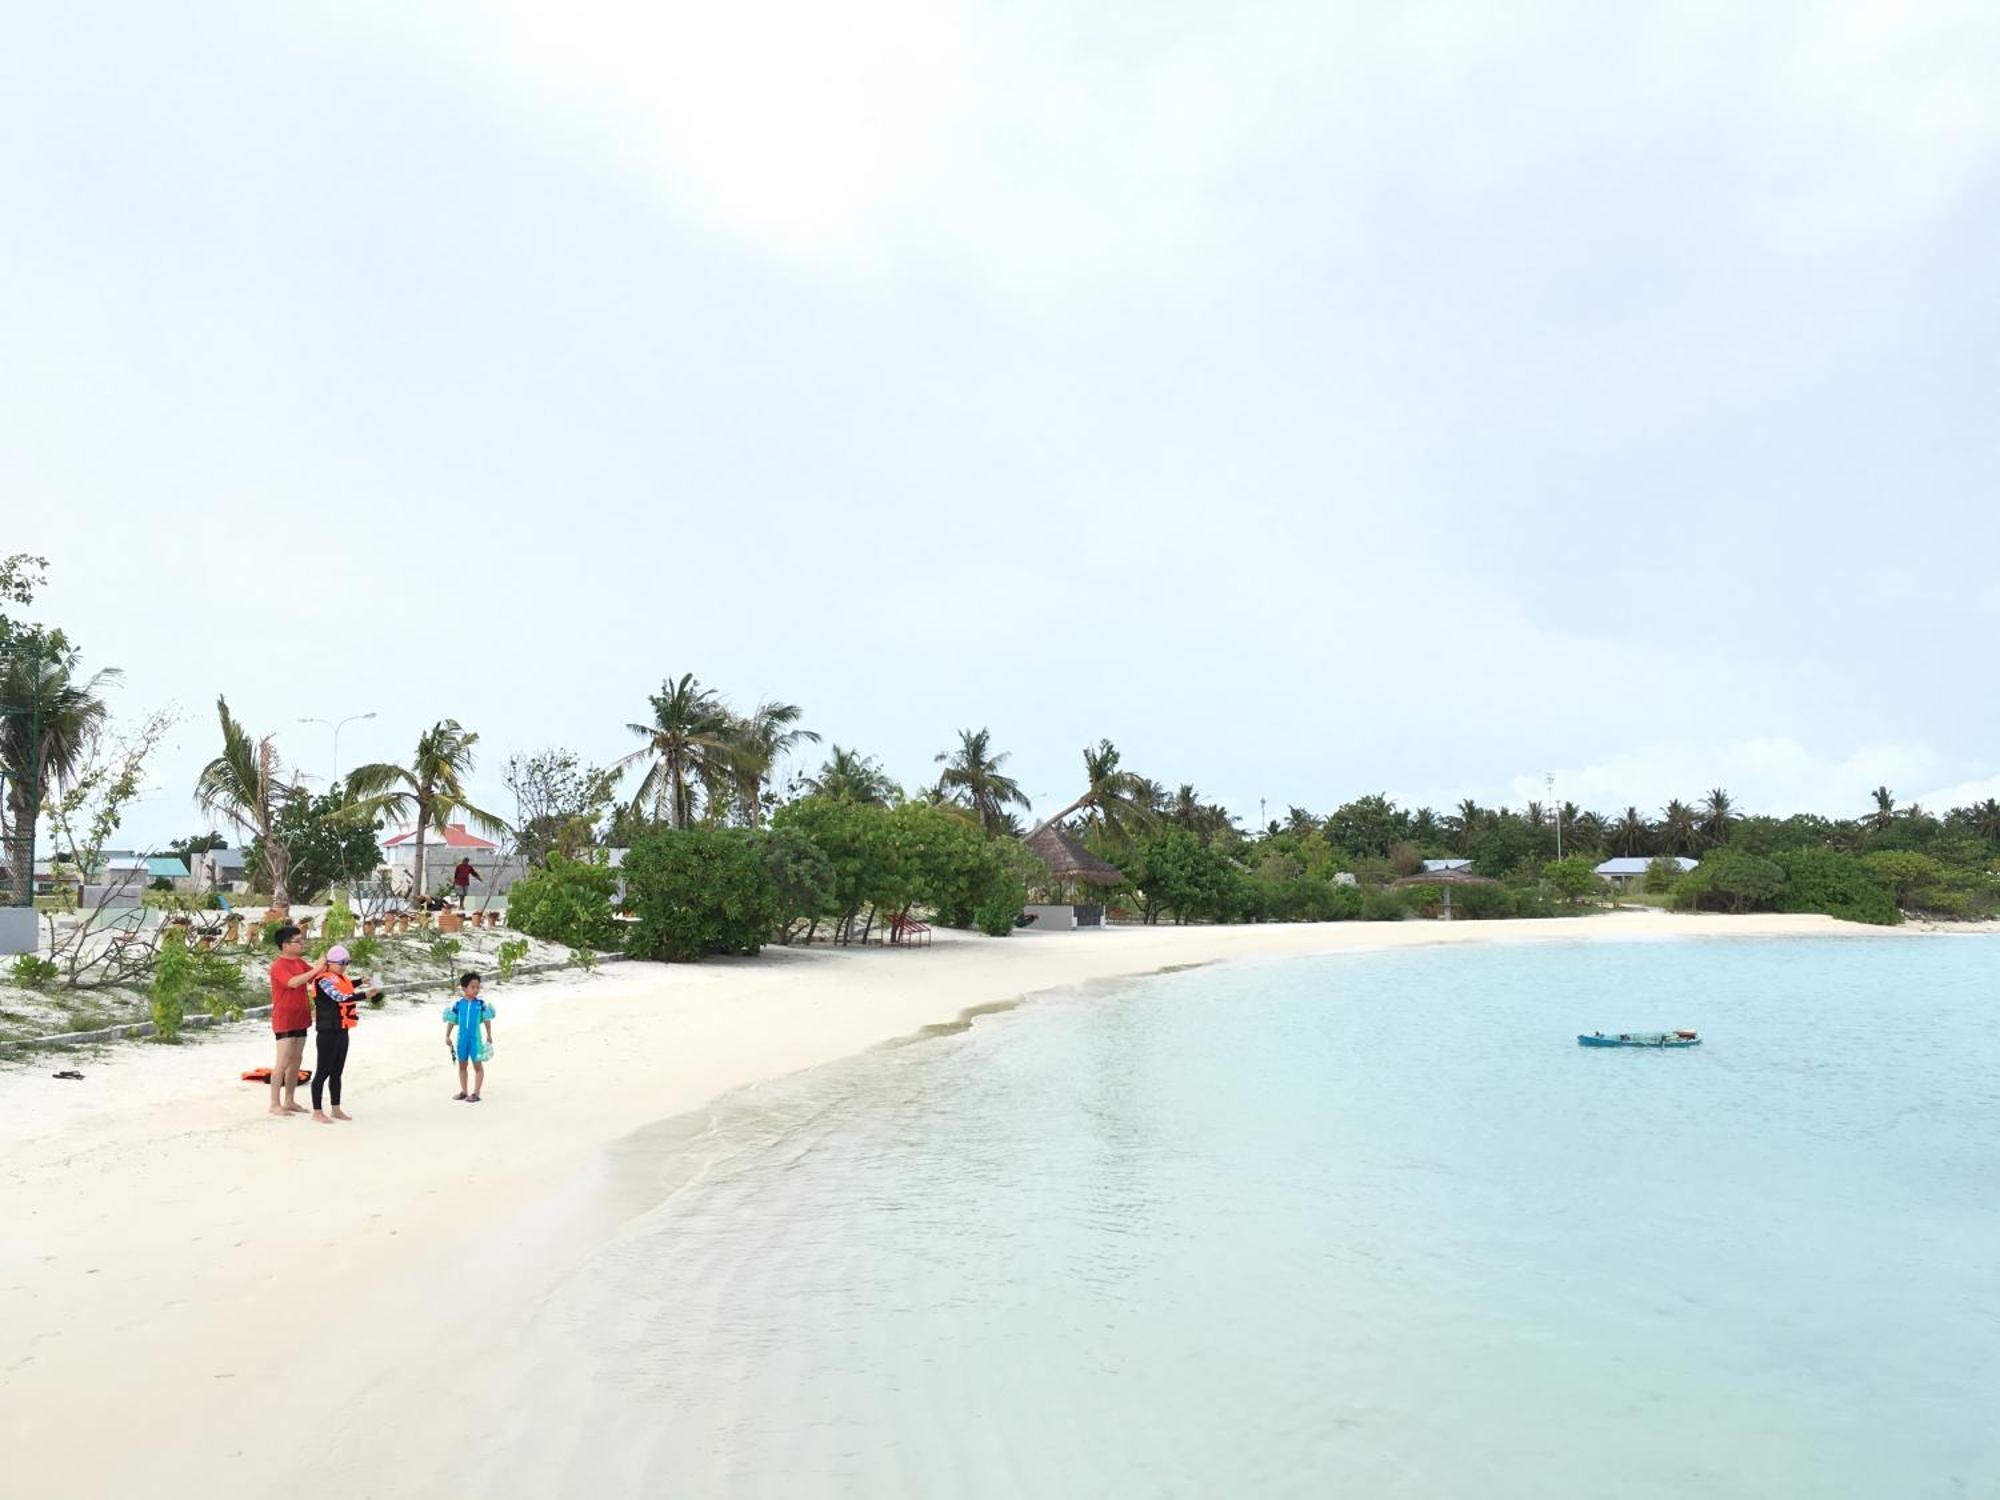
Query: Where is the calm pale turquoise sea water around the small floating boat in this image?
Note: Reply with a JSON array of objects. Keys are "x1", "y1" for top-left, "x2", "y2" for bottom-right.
[{"x1": 502, "y1": 938, "x2": 2000, "y2": 1500}]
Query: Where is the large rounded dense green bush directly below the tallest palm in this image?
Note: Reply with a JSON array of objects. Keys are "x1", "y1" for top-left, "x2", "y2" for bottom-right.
[{"x1": 622, "y1": 828, "x2": 782, "y2": 962}]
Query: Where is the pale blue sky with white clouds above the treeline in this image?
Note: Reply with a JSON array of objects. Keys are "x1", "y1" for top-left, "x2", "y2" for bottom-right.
[{"x1": 0, "y1": 0, "x2": 2000, "y2": 842}]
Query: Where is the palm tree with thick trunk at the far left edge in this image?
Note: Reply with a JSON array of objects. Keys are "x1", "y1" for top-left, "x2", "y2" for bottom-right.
[{"x1": 0, "y1": 648, "x2": 120, "y2": 904}]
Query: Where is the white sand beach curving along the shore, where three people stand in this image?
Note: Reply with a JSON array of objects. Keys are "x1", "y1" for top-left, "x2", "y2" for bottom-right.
[{"x1": 0, "y1": 914, "x2": 1960, "y2": 1500}]
